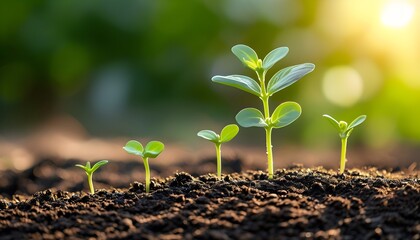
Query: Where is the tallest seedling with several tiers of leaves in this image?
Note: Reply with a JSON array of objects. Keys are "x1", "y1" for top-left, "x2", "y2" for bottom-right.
[{"x1": 212, "y1": 44, "x2": 315, "y2": 179}]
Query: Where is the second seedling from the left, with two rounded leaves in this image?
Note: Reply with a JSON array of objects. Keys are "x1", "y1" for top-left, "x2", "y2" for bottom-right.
[{"x1": 123, "y1": 140, "x2": 165, "y2": 193}]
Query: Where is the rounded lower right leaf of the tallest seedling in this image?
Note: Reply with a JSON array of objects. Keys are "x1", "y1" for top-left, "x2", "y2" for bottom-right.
[{"x1": 271, "y1": 102, "x2": 302, "y2": 128}]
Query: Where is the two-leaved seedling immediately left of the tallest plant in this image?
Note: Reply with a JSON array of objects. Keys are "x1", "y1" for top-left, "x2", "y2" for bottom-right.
[{"x1": 197, "y1": 124, "x2": 239, "y2": 180}]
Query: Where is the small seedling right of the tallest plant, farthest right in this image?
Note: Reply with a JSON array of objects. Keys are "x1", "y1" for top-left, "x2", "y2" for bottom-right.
[{"x1": 322, "y1": 114, "x2": 366, "y2": 174}]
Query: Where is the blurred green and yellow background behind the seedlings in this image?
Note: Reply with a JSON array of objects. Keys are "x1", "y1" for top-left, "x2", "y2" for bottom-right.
[{"x1": 0, "y1": 0, "x2": 420, "y2": 147}]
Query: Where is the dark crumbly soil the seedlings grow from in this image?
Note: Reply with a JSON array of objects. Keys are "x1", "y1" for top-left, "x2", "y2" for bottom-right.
[{"x1": 0, "y1": 161, "x2": 420, "y2": 239}]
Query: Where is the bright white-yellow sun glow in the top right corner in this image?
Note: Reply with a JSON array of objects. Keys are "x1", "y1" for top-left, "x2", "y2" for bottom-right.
[{"x1": 381, "y1": 0, "x2": 414, "y2": 28}]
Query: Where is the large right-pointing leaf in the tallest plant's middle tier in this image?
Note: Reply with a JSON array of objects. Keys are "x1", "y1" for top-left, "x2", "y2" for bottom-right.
[{"x1": 267, "y1": 63, "x2": 315, "y2": 95}]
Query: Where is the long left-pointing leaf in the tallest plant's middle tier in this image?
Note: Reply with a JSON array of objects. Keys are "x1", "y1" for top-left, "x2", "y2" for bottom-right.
[{"x1": 211, "y1": 75, "x2": 261, "y2": 97}]
